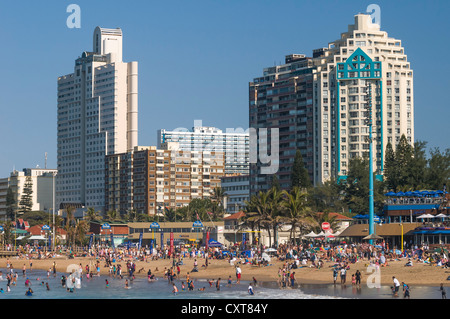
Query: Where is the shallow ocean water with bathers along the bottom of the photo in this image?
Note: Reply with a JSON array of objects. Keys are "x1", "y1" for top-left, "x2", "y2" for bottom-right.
[{"x1": 0, "y1": 270, "x2": 444, "y2": 301}]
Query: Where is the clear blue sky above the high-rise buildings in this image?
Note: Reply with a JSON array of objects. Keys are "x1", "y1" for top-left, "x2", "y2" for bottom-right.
[{"x1": 0, "y1": 0, "x2": 450, "y2": 177}]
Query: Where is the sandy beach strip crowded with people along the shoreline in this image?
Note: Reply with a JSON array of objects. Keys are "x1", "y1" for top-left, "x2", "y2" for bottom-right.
[{"x1": 0, "y1": 256, "x2": 450, "y2": 287}]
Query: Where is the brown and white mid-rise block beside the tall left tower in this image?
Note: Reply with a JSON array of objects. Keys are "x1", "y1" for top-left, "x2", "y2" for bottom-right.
[{"x1": 105, "y1": 142, "x2": 224, "y2": 215}]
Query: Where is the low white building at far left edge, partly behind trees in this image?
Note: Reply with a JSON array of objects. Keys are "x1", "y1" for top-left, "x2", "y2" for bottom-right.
[{"x1": 0, "y1": 168, "x2": 58, "y2": 218}]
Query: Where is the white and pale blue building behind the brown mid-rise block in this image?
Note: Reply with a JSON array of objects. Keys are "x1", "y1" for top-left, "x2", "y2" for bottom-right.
[{"x1": 157, "y1": 121, "x2": 249, "y2": 174}]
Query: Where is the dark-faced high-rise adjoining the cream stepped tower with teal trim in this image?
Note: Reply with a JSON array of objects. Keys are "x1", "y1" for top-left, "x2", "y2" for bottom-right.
[{"x1": 249, "y1": 54, "x2": 314, "y2": 193}]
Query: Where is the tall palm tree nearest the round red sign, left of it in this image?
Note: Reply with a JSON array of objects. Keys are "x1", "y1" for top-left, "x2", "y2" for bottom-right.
[{"x1": 283, "y1": 187, "x2": 312, "y2": 244}]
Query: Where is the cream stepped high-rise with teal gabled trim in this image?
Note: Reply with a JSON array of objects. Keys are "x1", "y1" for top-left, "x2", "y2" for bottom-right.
[{"x1": 313, "y1": 14, "x2": 414, "y2": 183}]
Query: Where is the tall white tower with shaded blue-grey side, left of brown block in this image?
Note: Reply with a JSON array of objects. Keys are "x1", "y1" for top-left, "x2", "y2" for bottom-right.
[{"x1": 56, "y1": 27, "x2": 138, "y2": 210}]
